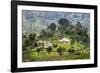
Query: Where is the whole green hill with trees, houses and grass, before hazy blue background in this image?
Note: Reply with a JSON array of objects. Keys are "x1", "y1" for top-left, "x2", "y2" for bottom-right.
[{"x1": 22, "y1": 18, "x2": 90, "y2": 62}]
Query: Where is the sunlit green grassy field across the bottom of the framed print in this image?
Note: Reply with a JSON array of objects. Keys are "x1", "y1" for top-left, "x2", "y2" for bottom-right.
[{"x1": 23, "y1": 40, "x2": 90, "y2": 62}]
